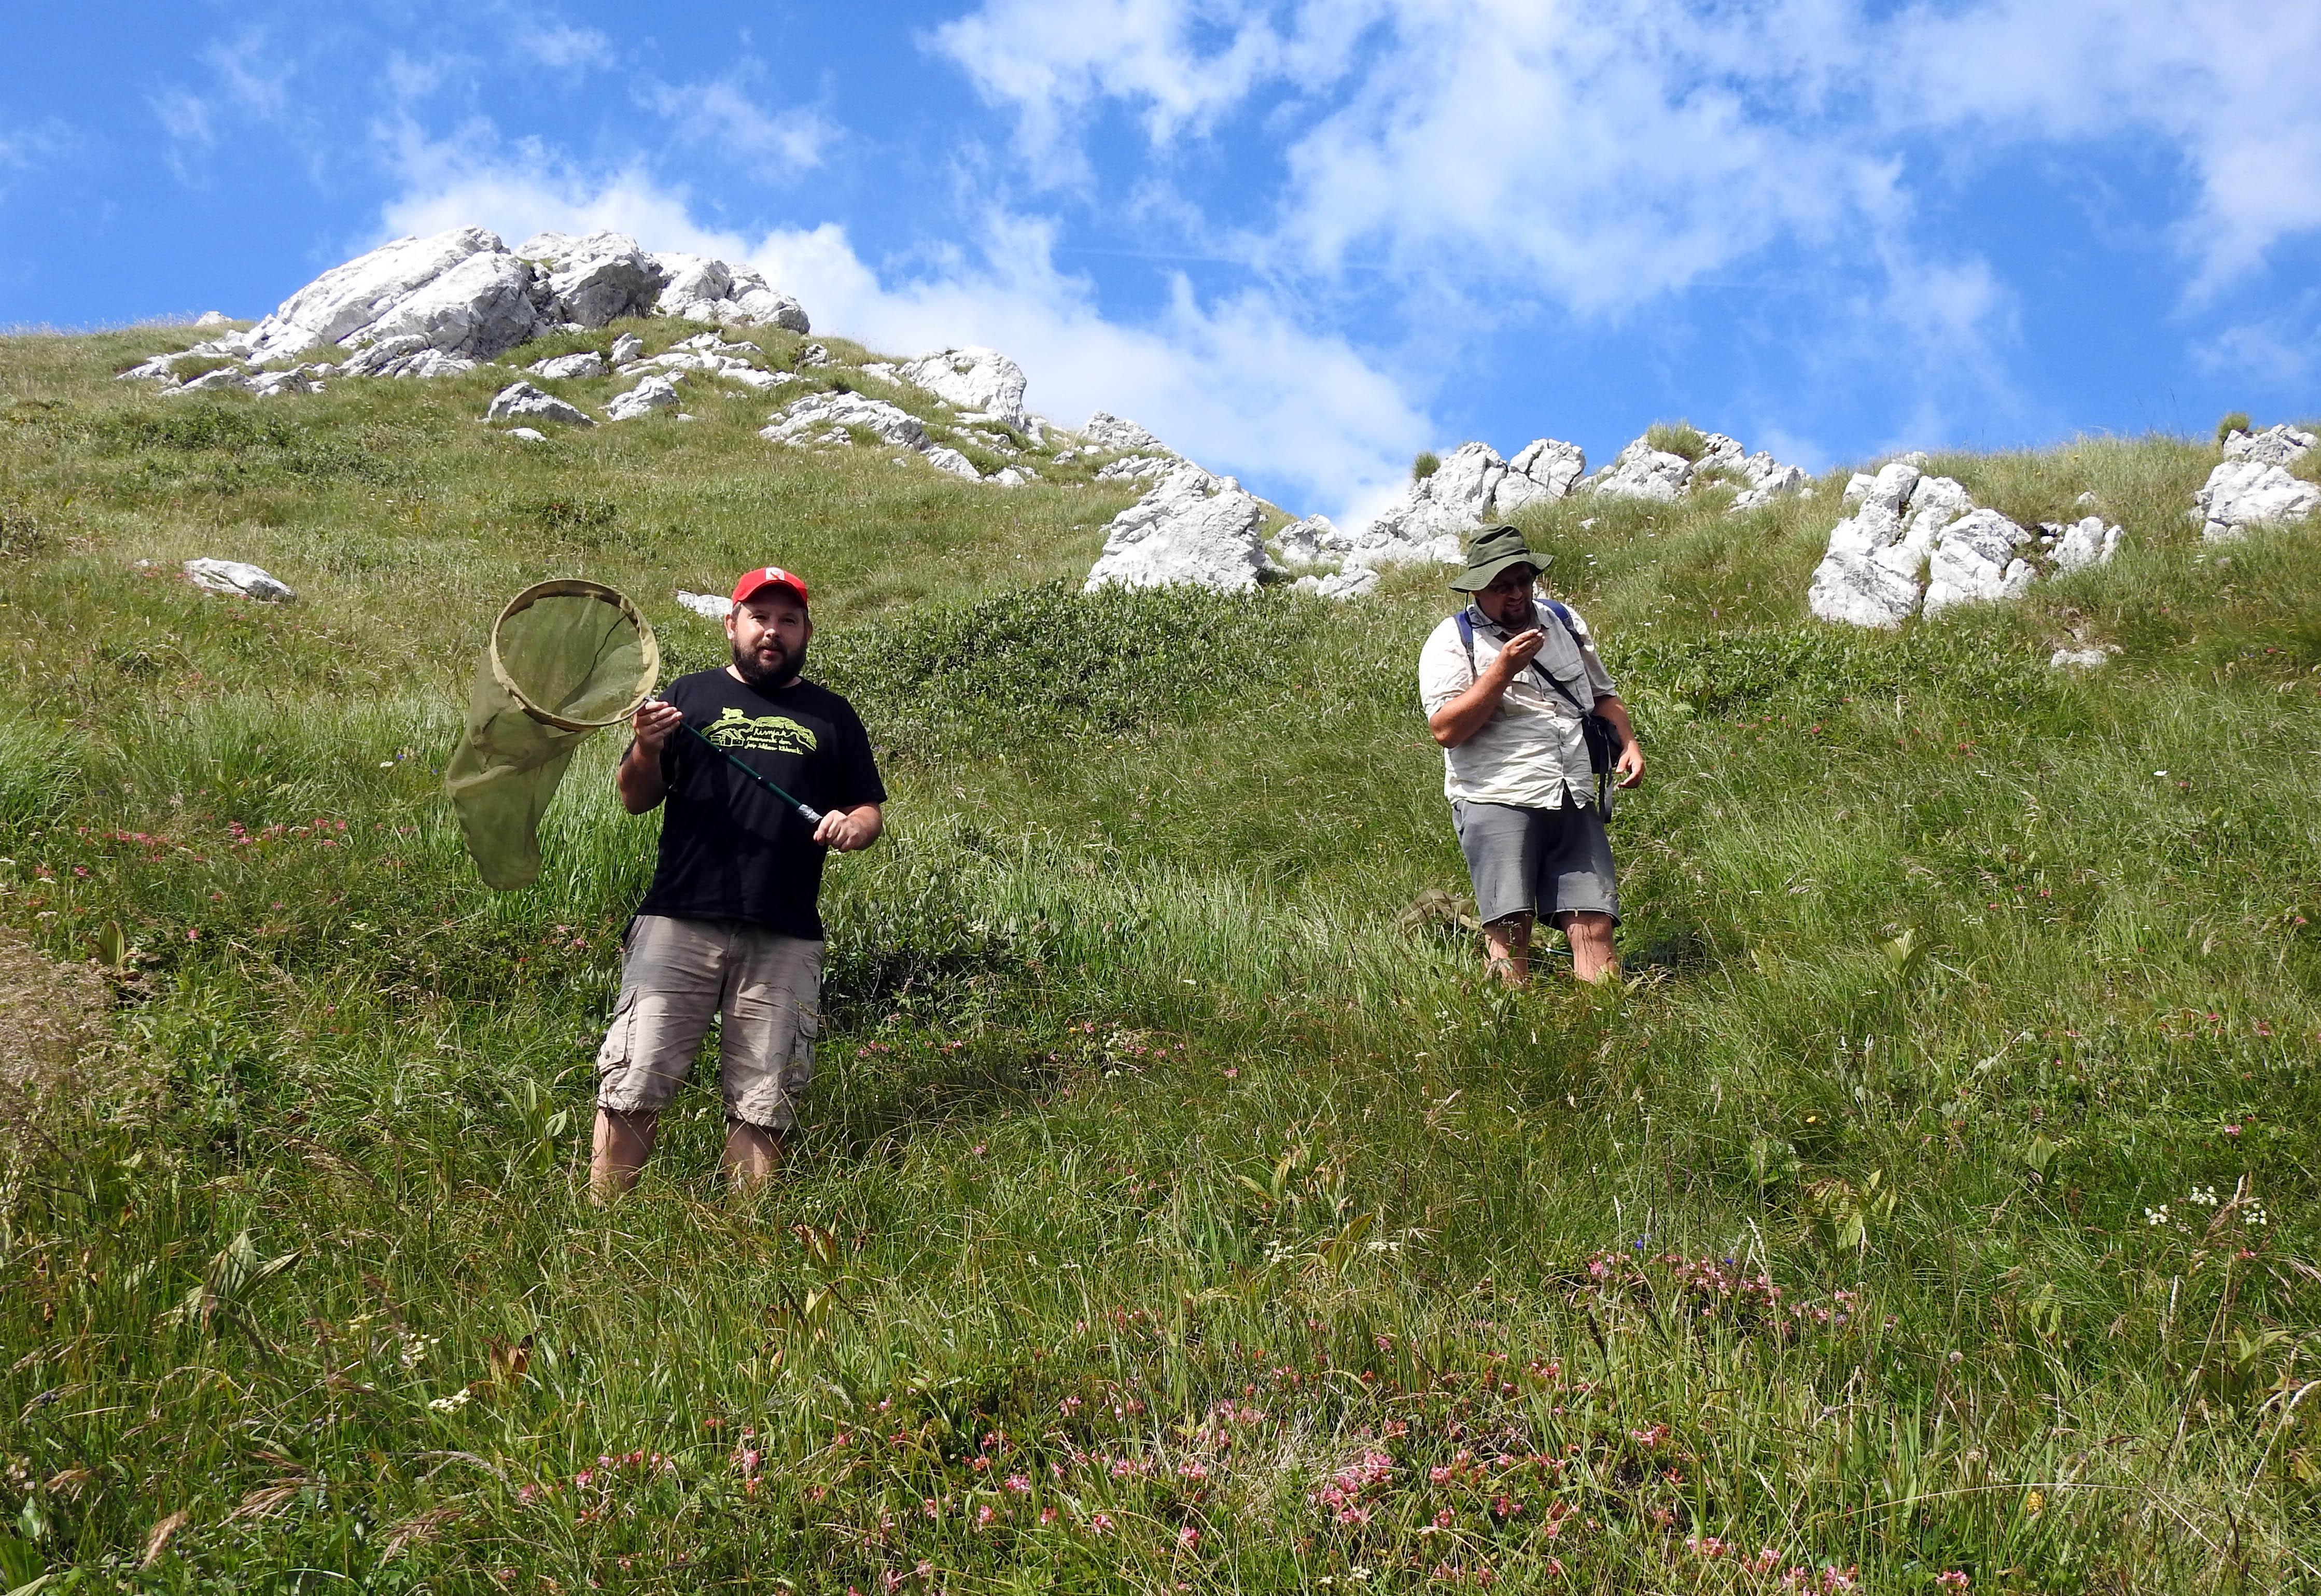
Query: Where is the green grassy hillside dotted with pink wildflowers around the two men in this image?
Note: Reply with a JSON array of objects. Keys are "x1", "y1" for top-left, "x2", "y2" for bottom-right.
[{"x1": 0, "y1": 325, "x2": 2321, "y2": 1596}]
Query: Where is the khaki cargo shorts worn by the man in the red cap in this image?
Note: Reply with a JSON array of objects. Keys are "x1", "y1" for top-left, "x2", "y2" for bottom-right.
[{"x1": 596, "y1": 914, "x2": 822, "y2": 1130}]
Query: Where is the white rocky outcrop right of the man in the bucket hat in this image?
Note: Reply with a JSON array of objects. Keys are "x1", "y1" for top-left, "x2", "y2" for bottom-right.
[{"x1": 1806, "y1": 455, "x2": 2121, "y2": 626}]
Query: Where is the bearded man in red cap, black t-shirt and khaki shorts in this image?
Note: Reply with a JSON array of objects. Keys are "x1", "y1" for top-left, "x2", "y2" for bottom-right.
[{"x1": 590, "y1": 566, "x2": 887, "y2": 1197}]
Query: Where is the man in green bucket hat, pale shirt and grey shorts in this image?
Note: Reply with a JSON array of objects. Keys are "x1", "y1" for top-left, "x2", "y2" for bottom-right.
[{"x1": 1418, "y1": 527, "x2": 1643, "y2": 986}]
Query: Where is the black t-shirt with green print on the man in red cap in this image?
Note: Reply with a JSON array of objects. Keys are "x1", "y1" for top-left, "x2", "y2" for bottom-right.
[{"x1": 636, "y1": 670, "x2": 887, "y2": 940}]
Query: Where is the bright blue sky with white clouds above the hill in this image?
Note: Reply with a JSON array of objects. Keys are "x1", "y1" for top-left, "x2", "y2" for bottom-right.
[{"x1": 0, "y1": 0, "x2": 2321, "y2": 515}]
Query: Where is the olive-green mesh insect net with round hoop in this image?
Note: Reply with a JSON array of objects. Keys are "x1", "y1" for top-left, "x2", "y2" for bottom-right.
[{"x1": 443, "y1": 578, "x2": 662, "y2": 891}]
